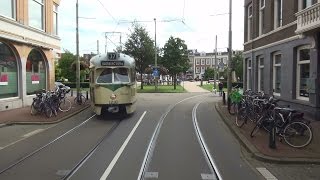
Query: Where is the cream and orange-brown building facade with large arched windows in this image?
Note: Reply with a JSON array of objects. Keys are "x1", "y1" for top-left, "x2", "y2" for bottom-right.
[{"x1": 0, "y1": 0, "x2": 60, "y2": 111}]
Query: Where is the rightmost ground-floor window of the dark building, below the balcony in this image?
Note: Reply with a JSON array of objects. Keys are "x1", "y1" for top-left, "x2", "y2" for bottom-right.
[{"x1": 297, "y1": 46, "x2": 310, "y2": 101}]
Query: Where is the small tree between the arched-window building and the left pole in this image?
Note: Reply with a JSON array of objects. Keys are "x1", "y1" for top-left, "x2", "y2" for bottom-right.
[{"x1": 59, "y1": 50, "x2": 76, "y2": 82}]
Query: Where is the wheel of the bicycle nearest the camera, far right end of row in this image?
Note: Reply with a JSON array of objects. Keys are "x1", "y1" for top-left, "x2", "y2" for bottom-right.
[{"x1": 283, "y1": 122, "x2": 312, "y2": 148}]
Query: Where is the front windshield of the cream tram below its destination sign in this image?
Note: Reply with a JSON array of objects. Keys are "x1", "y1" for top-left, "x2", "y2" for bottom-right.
[{"x1": 97, "y1": 68, "x2": 130, "y2": 83}]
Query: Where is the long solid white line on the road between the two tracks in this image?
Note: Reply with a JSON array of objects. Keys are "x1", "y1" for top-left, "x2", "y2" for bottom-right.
[{"x1": 100, "y1": 111, "x2": 147, "y2": 180}]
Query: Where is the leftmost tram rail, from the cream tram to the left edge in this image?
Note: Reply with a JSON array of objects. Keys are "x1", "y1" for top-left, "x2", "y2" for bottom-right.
[{"x1": 0, "y1": 115, "x2": 96, "y2": 175}]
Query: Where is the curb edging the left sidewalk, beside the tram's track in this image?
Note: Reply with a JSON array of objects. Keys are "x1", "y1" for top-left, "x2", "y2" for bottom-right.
[{"x1": 0, "y1": 105, "x2": 90, "y2": 128}]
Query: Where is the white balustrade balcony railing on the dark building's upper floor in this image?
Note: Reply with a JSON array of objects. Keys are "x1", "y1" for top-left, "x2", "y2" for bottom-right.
[{"x1": 296, "y1": 3, "x2": 320, "y2": 34}]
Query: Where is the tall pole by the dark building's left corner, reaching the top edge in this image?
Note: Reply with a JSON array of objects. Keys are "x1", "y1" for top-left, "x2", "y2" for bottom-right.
[{"x1": 227, "y1": 0, "x2": 232, "y2": 101}]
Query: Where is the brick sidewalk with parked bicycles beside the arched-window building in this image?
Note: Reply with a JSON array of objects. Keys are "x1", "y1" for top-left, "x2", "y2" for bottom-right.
[{"x1": 0, "y1": 97, "x2": 90, "y2": 127}]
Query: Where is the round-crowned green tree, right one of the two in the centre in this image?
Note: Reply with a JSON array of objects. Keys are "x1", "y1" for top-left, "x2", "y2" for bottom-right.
[{"x1": 161, "y1": 36, "x2": 190, "y2": 89}]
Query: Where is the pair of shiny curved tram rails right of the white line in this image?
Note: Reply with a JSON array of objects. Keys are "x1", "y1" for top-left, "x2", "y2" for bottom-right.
[{"x1": 137, "y1": 94, "x2": 222, "y2": 180}]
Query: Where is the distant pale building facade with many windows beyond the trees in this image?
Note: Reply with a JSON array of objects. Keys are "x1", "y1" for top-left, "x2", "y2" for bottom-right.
[{"x1": 187, "y1": 50, "x2": 228, "y2": 79}]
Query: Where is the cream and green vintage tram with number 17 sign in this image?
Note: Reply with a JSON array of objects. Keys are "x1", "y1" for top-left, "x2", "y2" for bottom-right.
[{"x1": 90, "y1": 52, "x2": 137, "y2": 115}]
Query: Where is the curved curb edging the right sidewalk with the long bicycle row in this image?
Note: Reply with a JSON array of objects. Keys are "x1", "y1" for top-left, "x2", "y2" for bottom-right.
[{"x1": 215, "y1": 103, "x2": 320, "y2": 164}]
